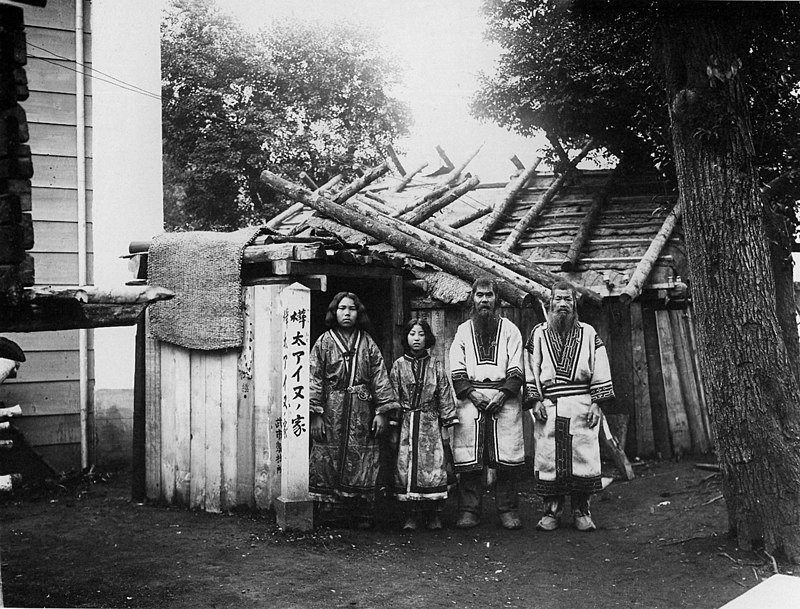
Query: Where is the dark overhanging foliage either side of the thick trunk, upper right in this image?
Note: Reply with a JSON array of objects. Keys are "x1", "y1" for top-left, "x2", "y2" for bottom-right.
[{"x1": 473, "y1": 0, "x2": 800, "y2": 182}]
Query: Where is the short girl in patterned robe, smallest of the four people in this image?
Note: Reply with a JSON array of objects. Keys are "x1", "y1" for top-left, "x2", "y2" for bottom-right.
[{"x1": 390, "y1": 318, "x2": 458, "y2": 531}]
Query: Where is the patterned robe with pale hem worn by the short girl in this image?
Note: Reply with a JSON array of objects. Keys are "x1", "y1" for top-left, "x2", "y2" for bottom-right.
[{"x1": 389, "y1": 354, "x2": 458, "y2": 501}]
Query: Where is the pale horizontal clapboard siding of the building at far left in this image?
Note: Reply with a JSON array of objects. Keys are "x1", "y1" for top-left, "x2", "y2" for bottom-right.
[{"x1": 1, "y1": 0, "x2": 94, "y2": 471}]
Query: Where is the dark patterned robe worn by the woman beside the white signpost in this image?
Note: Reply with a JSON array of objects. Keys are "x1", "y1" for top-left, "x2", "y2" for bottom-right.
[{"x1": 308, "y1": 330, "x2": 399, "y2": 501}]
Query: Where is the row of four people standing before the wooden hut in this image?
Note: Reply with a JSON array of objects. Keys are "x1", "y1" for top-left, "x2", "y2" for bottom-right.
[{"x1": 309, "y1": 279, "x2": 614, "y2": 531}]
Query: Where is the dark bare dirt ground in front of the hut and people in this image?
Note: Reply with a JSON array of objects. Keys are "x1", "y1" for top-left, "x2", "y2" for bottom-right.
[{"x1": 0, "y1": 461, "x2": 792, "y2": 609}]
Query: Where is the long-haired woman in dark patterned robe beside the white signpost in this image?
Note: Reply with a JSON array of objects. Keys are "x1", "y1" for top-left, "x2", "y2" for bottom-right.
[{"x1": 309, "y1": 292, "x2": 399, "y2": 529}]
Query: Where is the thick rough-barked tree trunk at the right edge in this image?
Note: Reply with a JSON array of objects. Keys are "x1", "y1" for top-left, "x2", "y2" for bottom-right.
[{"x1": 660, "y1": 8, "x2": 800, "y2": 562}]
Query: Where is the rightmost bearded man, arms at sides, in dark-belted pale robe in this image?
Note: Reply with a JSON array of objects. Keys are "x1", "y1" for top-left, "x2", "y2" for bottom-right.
[{"x1": 525, "y1": 282, "x2": 614, "y2": 531}]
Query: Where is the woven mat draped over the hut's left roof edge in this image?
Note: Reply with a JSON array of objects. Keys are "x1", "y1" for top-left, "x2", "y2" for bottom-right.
[{"x1": 147, "y1": 228, "x2": 264, "y2": 351}]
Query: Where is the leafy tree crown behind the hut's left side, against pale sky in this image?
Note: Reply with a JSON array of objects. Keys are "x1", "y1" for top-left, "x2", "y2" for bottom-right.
[{"x1": 161, "y1": 0, "x2": 410, "y2": 229}]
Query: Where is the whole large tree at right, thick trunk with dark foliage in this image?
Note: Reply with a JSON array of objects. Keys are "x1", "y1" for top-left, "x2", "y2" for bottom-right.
[{"x1": 475, "y1": 0, "x2": 800, "y2": 562}]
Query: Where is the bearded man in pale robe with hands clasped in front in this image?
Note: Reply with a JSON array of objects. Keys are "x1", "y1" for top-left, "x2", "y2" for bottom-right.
[{"x1": 450, "y1": 279, "x2": 525, "y2": 529}]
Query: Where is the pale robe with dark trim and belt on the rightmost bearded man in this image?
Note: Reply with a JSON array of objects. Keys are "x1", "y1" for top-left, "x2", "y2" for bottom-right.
[{"x1": 525, "y1": 322, "x2": 614, "y2": 496}]
